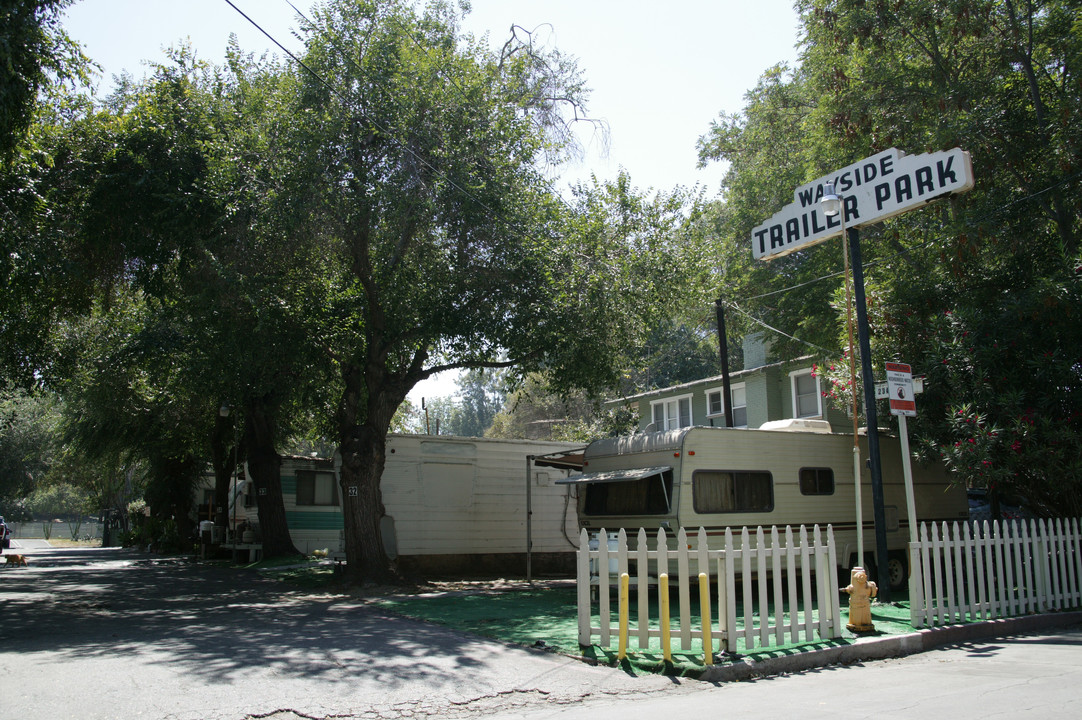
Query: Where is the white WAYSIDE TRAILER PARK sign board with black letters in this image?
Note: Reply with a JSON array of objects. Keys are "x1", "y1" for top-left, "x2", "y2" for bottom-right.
[{"x1": 751, "y1": 147, "x2": 973, "y2": 260}]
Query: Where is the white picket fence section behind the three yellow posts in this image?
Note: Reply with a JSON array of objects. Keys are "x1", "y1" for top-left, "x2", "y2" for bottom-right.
[{"x1": 577, "y1": 525, "x2": 842, "y2": 662}]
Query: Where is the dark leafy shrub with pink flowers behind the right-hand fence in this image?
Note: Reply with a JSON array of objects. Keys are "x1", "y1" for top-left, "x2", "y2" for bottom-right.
[{"x1": 814, "y1": 266, "x2": 1082, "y2": 515}]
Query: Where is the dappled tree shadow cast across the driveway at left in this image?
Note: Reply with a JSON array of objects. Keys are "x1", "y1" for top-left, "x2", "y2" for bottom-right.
[{"x1": 0, "y1": 548, "x2": 490, "y2": 690}]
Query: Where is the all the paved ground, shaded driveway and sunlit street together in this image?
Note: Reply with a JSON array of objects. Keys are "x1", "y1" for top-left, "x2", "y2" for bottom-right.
[{"x1": 0, "y1": 549, "x2": 1082, "y2": 720}]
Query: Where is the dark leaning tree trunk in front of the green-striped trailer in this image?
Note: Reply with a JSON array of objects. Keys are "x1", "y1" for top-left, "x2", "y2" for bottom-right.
[{"x1": 245, "y1": 398, "x2": 300, "y2": 558}]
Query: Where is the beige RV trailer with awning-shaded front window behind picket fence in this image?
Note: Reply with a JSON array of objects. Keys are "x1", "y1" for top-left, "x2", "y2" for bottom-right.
[{"x1": 556, "y1": 420, "x2": 968, "y2": 587}]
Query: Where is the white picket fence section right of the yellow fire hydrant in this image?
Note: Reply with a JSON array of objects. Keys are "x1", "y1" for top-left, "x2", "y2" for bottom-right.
[{"x1": 909, "y1": 519, "x2": 1082, "y2": 628}]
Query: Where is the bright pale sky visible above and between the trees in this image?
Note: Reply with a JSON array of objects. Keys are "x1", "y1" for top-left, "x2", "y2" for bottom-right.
[{"x1": 65, "y1": 0, "x2": 797, "y2": 404}]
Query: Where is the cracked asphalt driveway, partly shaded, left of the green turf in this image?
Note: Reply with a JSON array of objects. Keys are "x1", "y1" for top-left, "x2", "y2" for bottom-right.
[{"x1": 0, "y1": 549, "x2": 701, "y2": 720}]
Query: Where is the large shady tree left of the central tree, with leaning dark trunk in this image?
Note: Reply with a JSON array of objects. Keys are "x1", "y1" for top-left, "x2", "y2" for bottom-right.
[{"x1": 23, "y1": 48, "x2": 333, "y2": 557}]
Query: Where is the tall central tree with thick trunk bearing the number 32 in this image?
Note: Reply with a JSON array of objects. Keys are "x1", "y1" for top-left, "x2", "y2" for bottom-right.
[{"x1": 287, "y1": 1, "x2": 692, "y2": 580}]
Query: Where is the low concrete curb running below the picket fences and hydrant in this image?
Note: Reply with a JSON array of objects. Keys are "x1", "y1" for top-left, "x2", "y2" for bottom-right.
[{"x1": 699, "y1": 611, "x2": 1082, "y2": 682}]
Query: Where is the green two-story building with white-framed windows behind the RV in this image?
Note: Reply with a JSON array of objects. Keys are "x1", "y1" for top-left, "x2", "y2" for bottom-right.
[{"x1": 605, "y1": 332, "x2": 853, "y2": 433}]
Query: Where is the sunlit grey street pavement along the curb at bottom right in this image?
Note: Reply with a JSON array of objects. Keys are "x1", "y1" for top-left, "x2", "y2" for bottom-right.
[{"x1": 500, "y1": 628, "x2": 1082, "y2": 720}]
